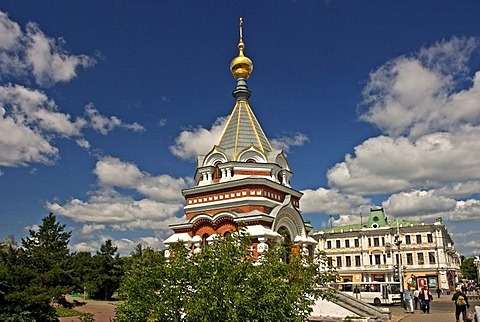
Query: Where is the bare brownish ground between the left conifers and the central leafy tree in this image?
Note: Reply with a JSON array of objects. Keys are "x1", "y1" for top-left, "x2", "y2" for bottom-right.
[{"x1": 60, "y1": 296, "x2": 119, "y2": 322}]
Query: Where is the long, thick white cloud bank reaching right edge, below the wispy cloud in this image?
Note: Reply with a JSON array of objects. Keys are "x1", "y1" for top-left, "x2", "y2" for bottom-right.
[{"x1": 327, "y1": 126, "x2": 480, "y2": 194}]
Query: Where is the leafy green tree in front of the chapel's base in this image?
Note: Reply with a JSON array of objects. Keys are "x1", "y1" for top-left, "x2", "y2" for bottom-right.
[{"x1": 117, "y1": 233, "x2": 335, "y2": 322}]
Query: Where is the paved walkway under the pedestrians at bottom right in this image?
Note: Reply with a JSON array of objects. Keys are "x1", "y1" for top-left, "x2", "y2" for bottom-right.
[{"x1": 390, "y1": 294, "x2": 480, "y2": 322}]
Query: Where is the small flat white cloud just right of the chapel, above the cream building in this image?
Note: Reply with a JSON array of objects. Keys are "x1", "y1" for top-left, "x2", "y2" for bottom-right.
[{"x1": 300, "y1": 188, "x2": 370, "y2": 214}]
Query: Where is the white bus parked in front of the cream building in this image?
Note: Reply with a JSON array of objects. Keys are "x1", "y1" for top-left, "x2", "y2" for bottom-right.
[{"x1": 335, "y1": 282, "x2": 402, "y2": 306}]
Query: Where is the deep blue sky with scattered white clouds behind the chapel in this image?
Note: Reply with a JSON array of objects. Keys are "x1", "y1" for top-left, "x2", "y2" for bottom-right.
[{"x1": 0, "y1": 0, "x2": 480, "y2": 256}]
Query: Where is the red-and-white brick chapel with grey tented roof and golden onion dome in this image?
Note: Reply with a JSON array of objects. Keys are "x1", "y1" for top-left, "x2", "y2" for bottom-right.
[{"x1": 164, "y1": 18, "x2": 316, "y2": 255}]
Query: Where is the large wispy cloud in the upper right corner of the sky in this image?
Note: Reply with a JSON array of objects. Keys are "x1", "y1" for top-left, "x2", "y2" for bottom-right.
[{"x1": 360, "y1": 37, "x2": 480, "y2": 138}]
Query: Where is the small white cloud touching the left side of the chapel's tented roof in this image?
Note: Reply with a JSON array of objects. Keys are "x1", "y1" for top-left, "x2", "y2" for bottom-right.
[{"x1": 170, "y1": 117, "x2": 228, "y2": 160}]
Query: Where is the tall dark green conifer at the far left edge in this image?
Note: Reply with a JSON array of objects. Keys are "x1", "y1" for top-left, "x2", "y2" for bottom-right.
[{"x1": 0, "y1": 213, "x2": 72, "y2": 321}]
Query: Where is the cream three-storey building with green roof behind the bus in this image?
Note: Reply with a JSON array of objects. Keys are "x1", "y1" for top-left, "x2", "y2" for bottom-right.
[{"x1": 313, "y1": 208, "x2": 461, "y2": 289}]
